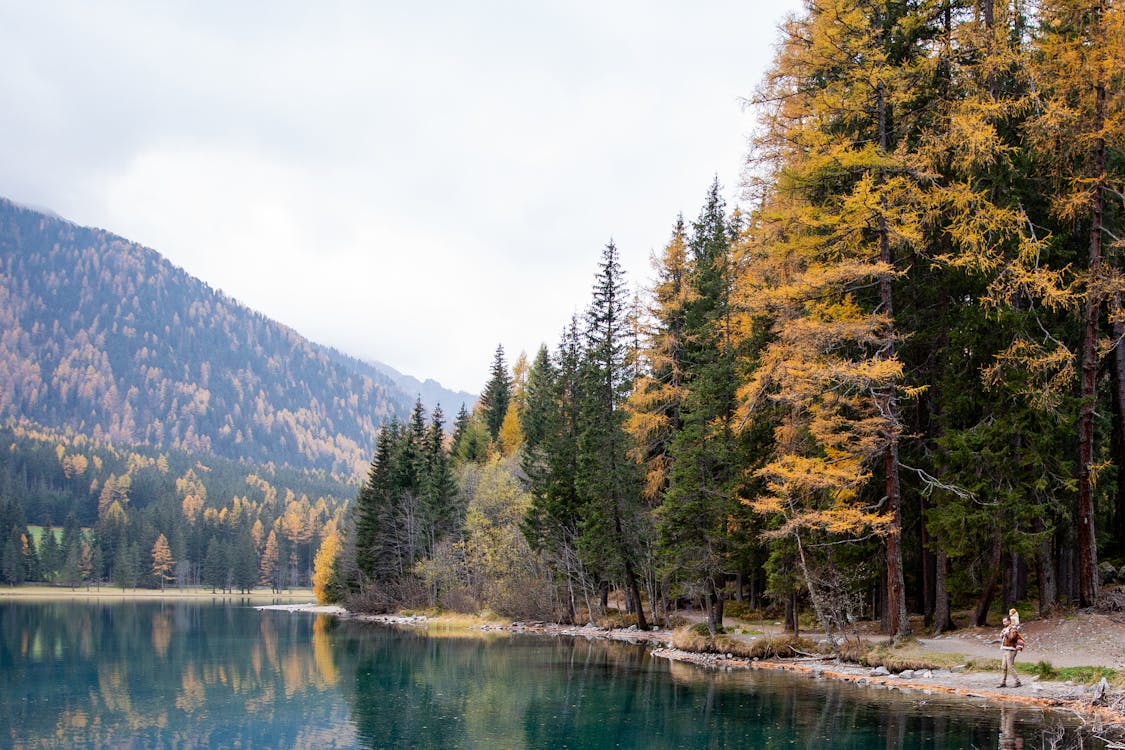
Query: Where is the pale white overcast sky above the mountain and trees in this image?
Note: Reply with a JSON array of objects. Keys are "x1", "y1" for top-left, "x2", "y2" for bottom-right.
[{"x1": 0, "y1": 0, "x2": 801, "y2": 392}]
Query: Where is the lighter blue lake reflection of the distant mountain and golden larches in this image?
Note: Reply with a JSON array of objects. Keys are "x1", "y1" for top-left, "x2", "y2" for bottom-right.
[{"x1": 0, "y1": 602, "x2": 357, "y2": 748}]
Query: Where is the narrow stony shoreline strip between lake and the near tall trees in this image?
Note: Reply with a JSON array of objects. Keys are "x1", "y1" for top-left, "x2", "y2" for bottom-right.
[{"x1": 321, "y1": 607, "x2": 1125, "y2": 748}]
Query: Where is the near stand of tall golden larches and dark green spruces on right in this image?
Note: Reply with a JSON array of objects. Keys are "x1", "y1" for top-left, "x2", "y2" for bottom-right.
[{"x1": 328, "y1": 0, "x2": 1125, "y2": 640}]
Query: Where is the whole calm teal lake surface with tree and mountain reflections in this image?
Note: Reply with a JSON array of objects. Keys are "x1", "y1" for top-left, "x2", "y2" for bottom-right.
[{"x1": 0, "y1": 600, "x2": 1104, "y2": 750}]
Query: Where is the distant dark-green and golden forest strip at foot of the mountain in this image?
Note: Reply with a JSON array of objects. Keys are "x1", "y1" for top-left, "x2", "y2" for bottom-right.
[{"x1": 0, "y1": 421, "x2": 354, "y2": 593}]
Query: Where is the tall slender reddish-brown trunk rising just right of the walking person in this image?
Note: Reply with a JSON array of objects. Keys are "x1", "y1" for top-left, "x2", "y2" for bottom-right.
[{"x1": 1078, "y1": 67, "x2": 1106, "y2": 607}]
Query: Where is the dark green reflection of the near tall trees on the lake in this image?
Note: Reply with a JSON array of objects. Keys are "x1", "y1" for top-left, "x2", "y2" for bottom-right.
[{"x1": 340, "y1": 633, "x2": 1104, "y2": 750}]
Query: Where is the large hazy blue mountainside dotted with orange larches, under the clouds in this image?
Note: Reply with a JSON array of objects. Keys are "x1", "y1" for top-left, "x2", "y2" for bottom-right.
[{"x1": 0, "y1": 193, "x2": 420, "y2": 477}]
